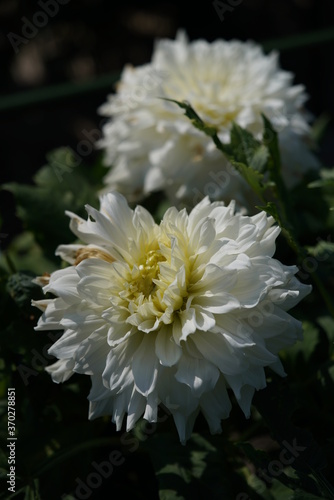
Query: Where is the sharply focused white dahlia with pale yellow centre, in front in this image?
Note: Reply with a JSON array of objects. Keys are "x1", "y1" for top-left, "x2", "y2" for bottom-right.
[{"x1": 34, "y1": 193, "x2": 310, "y2": 442}]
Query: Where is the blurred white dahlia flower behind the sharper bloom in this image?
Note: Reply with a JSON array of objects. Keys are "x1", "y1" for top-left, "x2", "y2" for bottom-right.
[{"x1": 98, "y1": 33, "x2": 318, "y2": 210}]
